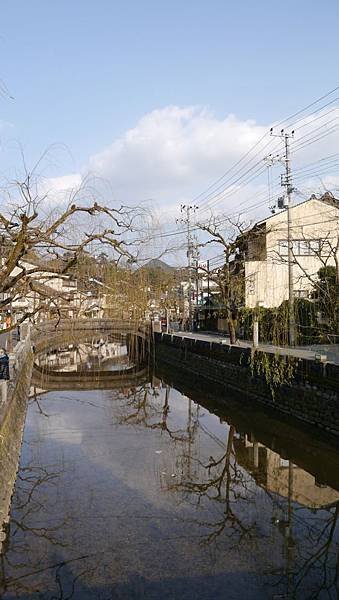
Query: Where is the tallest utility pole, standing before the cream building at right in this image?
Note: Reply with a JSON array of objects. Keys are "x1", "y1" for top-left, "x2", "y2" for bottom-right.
[{"x1": 271, "y1": 129, "x2": 295, "y2": 346}]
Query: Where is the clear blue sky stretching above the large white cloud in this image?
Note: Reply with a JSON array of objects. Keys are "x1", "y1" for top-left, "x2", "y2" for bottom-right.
[{"x1": 0, "y1": 0, "x2": 339, "y2": 240}]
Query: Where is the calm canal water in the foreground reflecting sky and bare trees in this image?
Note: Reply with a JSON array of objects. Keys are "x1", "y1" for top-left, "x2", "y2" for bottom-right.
[{"x1": 0, "y1": 342, "x2": 339, "y2": 600}]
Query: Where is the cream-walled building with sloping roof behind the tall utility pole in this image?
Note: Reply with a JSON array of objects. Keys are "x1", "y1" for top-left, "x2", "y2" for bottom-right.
[{"x1": 243, "y1": 193, "x2": 339, "y2": 308}]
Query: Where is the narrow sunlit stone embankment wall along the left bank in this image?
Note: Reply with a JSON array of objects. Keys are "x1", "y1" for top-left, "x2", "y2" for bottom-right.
[{"x1": 0, "y1": 336, "x2": 33, "y2": 554}]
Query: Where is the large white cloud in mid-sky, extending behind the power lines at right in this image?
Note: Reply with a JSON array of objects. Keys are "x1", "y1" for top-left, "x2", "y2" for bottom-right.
[{"x1": 29, "y1": 106, "x2": 339, "y2": 258}]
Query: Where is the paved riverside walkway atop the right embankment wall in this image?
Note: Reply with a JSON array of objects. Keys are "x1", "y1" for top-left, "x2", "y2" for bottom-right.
[{"x1": 170, "y1": 331, "x2": 339, "y2": 365}]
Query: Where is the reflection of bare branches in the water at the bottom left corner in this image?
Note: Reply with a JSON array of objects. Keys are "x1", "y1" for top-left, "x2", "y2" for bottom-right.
[{"x1": 0, "y1": 454, "x2": 107, "y2": 600}]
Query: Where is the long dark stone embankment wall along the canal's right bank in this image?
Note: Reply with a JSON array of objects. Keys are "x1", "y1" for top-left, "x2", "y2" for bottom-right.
[{"x1": 154, "y1": 333, "x2": 339, "y2": 438}]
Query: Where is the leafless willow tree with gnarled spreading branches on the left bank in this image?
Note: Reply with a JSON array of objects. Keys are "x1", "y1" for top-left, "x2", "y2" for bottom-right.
[{"x1": 0, "y1": 174, "x2": 146, "y2": 328}]
